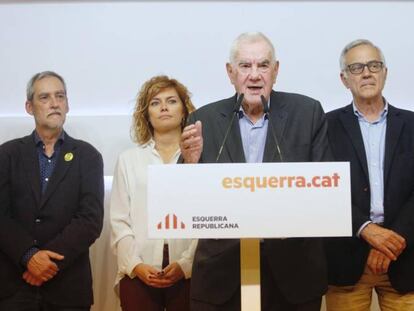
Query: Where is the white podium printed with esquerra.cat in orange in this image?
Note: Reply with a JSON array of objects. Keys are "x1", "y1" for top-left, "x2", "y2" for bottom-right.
[{"x1": 147, "y1": 162, "x2": 352, "y2": 311}]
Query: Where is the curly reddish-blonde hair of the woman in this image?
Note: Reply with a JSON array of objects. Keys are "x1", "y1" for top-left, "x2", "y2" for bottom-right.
[{"x1": 131, "y1": 76, "x2": 195, "y2": 145}]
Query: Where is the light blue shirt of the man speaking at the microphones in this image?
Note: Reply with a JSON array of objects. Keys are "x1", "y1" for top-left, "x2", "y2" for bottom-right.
[{"x1": 239, "y1": 107, "x2": 269, "y2": 163}]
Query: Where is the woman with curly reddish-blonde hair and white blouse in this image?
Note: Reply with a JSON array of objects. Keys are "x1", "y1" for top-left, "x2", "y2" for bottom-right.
[{"x1": 110, "y1": 76, "x2": 197, "y2": 311}]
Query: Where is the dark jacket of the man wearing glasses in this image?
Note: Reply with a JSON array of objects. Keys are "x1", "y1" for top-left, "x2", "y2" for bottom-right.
[{"x1": 326, "y1": 105, "x2": 414, "y2": 293}]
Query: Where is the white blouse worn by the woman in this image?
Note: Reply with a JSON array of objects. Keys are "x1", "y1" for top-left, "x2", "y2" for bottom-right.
[{"x1": 110, "y1": 140, "x2": 197, "y2": 284}]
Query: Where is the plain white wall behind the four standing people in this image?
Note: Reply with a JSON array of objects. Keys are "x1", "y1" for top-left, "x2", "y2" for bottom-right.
[{"x1": 0, "y1": 0, "x2": 408, "y2": 311}]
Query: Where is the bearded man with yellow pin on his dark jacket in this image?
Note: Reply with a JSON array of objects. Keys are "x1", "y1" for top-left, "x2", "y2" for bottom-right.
[{"x1": 0, "y1": 71, "x2": 104, "y2": 311}]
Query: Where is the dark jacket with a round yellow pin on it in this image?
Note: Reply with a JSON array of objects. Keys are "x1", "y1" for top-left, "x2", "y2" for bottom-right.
[{"x1": 0, "y1": 134, "x2": 104, "y2": 306}]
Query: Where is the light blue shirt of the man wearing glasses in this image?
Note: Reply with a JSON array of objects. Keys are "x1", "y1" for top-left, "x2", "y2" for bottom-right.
[{"x1": 353, "y1": 100, "x2": 388, "y2": 235}]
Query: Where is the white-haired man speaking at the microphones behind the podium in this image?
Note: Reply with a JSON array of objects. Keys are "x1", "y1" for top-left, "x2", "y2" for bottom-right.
[{"x1": 181, "y1": 33, "x2": 329, "y2": 311}]
